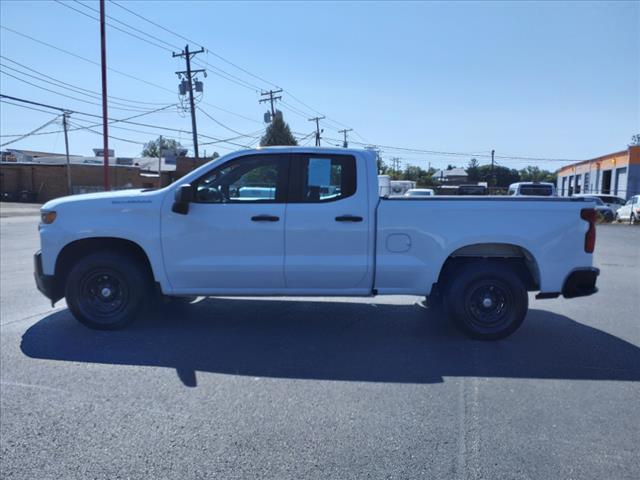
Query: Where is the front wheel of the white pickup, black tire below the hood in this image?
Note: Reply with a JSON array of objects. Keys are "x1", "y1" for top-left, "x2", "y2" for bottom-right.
[{"x1": 65, "y1": 252, "x2": 151, "y2": 330}]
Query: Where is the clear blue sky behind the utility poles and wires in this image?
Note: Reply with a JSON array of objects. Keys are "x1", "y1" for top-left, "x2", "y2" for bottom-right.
[{"x1": 0, "y1": 0, "x2": 640, "y2": 169}]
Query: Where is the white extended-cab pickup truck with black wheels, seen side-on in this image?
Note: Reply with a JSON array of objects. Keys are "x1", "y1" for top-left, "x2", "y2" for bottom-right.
[{"x1": 35, "y1": 147, "x2": 599, "y2": 339}]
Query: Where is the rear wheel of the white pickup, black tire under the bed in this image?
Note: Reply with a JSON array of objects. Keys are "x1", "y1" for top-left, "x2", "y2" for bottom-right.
[{"x1": 445, "y1": 261, "x2": 529, "y2": 340}]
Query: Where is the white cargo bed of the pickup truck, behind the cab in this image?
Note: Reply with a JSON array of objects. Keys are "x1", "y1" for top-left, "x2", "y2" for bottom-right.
[{"x1": 375, "y1": 196, "x2": 593, "y2": 295}]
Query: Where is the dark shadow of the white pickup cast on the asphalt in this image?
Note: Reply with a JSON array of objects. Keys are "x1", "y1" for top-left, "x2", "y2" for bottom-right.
[{"x1": 21, "y1": 298, "x2": 640, "y2": 387}]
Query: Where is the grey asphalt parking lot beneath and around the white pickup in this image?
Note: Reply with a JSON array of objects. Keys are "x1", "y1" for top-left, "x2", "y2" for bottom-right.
[{"x1": 0, "y1": 212, "x2": 640, "y2": 480}]
